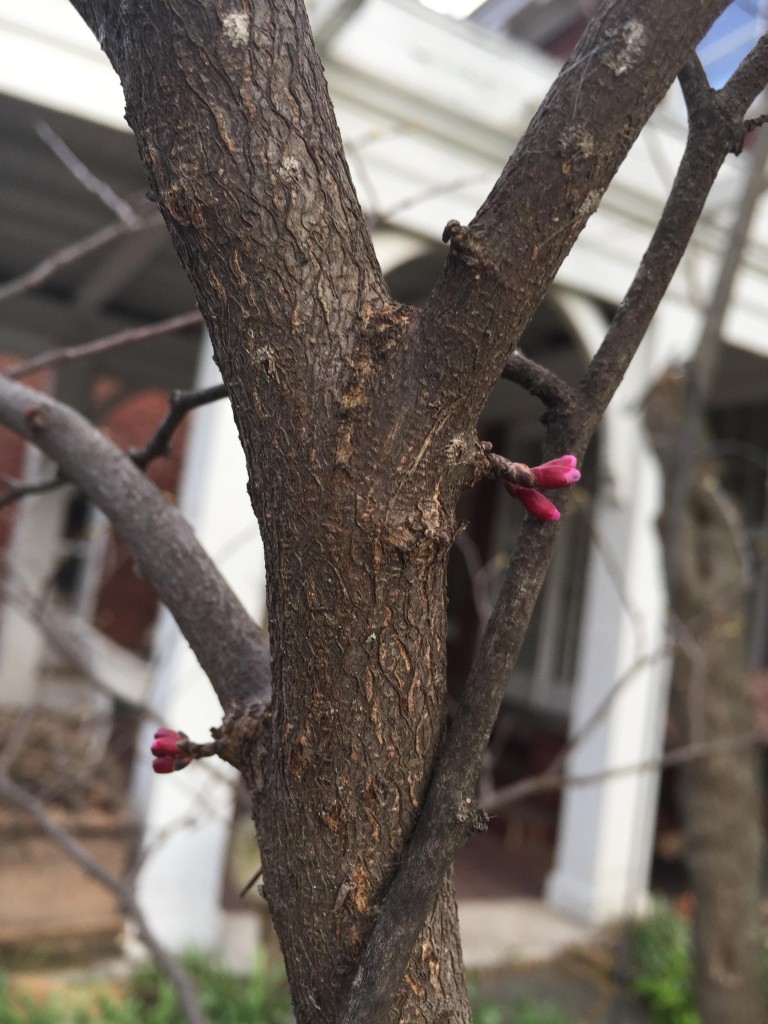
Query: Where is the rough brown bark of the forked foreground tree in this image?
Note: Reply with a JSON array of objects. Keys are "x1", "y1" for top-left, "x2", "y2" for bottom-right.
[{"x1": 0, "y1": 0, "x2": 765, "y2": 1024}]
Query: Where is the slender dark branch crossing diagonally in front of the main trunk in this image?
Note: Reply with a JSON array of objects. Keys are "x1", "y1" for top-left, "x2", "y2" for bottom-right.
[{"x1": 344, "y1": 29, "x2": 768, "y2": 1024}]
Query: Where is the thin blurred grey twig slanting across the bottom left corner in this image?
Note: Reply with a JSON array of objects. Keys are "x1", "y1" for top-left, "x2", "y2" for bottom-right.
[{"x1": 0, "y1": 771, "x2": 207, "y2": 1024}]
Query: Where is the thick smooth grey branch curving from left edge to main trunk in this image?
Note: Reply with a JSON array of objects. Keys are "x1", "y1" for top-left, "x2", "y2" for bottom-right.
[{"x1": 0, "y1": 377, "x2": 270, "y2": 710}]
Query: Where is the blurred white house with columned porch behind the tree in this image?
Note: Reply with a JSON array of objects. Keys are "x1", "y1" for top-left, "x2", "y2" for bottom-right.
[{"x1": 0, "y1": 0, "x2": 768, "y2": 958}]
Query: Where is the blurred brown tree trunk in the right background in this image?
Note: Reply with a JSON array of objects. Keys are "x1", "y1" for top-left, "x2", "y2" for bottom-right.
[{"x1": 649, "y1": 376, "x2": 766, "y2": 1024}]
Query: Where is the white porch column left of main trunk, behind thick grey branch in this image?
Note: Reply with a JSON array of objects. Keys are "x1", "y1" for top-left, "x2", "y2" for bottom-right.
[{"x1": 134, "y1": 344, "x2": 264, "y2": 951}]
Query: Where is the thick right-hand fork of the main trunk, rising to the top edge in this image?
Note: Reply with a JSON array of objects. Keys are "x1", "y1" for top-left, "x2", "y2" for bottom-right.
[{"x1": 409, "y1": 0, "x2": 727, "y2": 432}]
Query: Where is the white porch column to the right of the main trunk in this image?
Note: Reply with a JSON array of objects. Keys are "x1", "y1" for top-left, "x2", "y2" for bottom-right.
[{"x1": 546, "y1": 397, "x2": 668, "y2": 924}]
